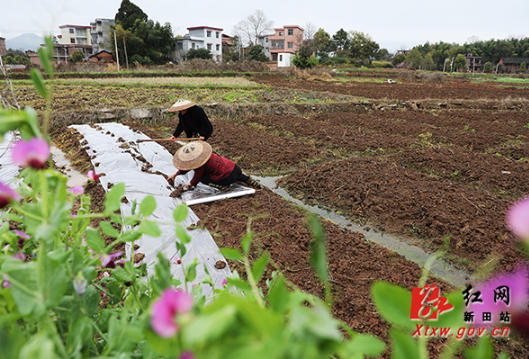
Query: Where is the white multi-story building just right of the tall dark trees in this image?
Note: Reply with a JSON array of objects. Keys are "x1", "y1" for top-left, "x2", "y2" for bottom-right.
[{"x1": 172, "y1": 26, "x2": 222, "y2": 62}]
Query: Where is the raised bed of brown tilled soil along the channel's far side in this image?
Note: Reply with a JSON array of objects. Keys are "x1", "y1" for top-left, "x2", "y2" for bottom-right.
[{"x1": 280, "y1": 158, "x2": 523, "y2": 269}]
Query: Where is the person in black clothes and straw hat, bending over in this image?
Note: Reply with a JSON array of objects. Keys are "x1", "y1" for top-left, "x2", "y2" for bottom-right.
[{"x1": 169, "y1": 99, "x2": 213, "y2": 141}]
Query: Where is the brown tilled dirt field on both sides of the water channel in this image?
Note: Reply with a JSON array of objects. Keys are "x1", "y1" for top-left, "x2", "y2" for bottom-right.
[{"x1": 42, "y1": 74, "x2": 529, "y2": 358}]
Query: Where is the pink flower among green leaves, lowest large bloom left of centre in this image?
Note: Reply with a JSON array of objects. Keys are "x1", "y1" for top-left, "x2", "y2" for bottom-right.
[{"x1": 151, "y1": 289, "x2": 193, "y2": 338}]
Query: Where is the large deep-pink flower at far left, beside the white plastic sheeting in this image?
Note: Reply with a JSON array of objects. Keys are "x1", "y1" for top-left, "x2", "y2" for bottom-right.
[{"x1": 11, "y1": 137, "x2": 50, "y2": 170}]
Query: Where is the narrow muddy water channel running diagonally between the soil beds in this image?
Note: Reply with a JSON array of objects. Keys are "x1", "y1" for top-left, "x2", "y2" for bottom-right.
[{"x1": 252, "y1": 175, "x2": 472, "y2": 287}]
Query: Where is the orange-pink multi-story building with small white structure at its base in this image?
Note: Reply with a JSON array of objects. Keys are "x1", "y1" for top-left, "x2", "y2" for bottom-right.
[{"x1": 267, "y1": 25, "x2": 304, "y2": 67}]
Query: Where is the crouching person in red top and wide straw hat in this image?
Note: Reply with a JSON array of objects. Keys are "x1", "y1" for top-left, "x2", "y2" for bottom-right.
[{"x1": 168, "y1": 141, "x2": 261, "y2": 190}]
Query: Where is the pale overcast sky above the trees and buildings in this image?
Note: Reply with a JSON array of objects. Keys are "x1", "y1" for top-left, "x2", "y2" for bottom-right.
[{"x1": 0, "y1": 0, "x2": 529, "y2": 52}]
